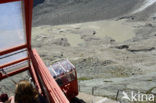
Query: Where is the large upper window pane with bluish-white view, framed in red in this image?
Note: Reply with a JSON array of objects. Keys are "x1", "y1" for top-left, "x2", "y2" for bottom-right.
[{"x1": 0, "y1": 1, "x2": 26, "y2": 50}]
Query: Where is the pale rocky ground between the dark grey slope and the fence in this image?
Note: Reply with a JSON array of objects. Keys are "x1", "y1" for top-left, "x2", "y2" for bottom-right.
[{"x1": 32, "y1": 19, "x2": 156, "y2": 103}]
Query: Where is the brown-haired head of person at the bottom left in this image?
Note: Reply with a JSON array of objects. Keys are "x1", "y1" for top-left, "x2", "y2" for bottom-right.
[{"x1": 15, "y1": 80, "x2": 38, "y2": 103}]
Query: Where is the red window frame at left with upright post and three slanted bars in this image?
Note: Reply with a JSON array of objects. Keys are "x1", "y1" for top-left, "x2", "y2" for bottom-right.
[{"x1": 0, "y1": 0, "x2": 33, "y2": 80}]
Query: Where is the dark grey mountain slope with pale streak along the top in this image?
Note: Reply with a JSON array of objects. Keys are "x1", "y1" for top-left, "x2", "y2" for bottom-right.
[{"x1": 33, "y1": 0, "x2": 156, "y2": 26}]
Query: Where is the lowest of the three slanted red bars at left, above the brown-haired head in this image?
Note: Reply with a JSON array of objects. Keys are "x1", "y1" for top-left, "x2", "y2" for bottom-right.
[{"x1": 0, "y1": 67, "x2": 29, "y2": 80}]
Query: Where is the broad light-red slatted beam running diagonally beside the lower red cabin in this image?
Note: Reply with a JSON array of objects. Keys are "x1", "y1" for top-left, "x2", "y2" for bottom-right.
[{"x1": 30, "y1": 50, "x2": 69, "y2": 103}]
